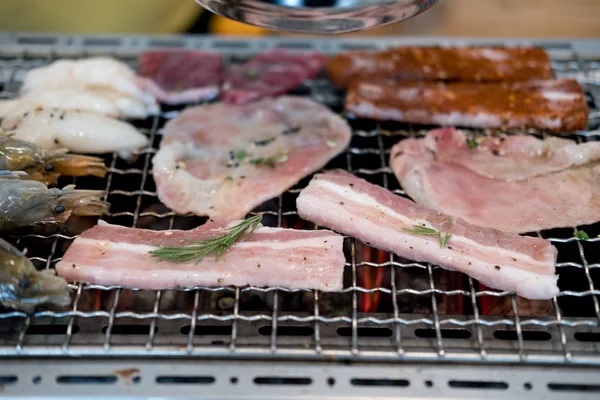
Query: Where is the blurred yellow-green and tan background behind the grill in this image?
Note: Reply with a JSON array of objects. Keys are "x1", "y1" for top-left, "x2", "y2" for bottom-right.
[{"x1": 0, "y1": 0, "x2": 600, "y2": 38}]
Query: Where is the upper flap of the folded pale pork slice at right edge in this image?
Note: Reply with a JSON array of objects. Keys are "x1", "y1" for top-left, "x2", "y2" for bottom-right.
[{"x1": 423, "y1": 128, "x2": 600, "y2": 181}]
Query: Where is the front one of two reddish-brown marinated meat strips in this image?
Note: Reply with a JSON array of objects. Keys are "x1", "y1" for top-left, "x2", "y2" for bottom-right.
[{"x1": 346, "y1": 79, "x2": 588, "y2": 132}]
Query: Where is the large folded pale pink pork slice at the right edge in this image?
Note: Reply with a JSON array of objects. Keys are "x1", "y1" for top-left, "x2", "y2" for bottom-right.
[{"x1": 390, "y1": 131, "x2": 600, "y2": 233}]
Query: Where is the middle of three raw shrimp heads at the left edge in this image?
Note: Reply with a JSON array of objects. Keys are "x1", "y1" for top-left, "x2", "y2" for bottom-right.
[{"x1": 0, "y1": 173, "x2": 109, "y2": 231}]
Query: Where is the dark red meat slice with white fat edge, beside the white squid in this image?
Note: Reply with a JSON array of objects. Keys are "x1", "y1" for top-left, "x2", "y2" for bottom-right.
[{"x1": 138, "y1": 50, "x2": 223, "y2": 104}]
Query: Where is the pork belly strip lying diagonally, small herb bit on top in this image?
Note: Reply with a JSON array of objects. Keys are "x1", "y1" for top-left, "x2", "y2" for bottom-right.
[{"x1": 297, "y1": 172, "x2": 558, "y2": 299}]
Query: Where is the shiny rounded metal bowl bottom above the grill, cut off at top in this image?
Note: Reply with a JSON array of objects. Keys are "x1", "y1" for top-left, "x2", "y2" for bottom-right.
[{"x1": 195, "y1": 0, "x2": 438, "y2": 34}]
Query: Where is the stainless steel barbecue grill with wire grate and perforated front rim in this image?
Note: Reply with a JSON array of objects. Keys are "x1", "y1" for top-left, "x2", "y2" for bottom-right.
[{"x1": 0, "y1": 33, "x2": 600, "y2": 399}]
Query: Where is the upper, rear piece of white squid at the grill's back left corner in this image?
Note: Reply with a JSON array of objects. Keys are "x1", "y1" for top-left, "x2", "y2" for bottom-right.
[{"x1": 21, "y1": 57, "x2": 159, "y2": 118}]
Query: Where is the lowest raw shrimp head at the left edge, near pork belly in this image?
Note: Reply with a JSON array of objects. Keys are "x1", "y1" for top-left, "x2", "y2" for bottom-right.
[{"x1": 0, "y1": 239, "x2": 71, "y2": 312}]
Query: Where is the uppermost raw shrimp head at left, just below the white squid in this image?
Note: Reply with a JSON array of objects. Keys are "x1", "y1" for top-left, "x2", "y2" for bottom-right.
[{"x1": 0, "y1": 135, "x2": 106, "y2": 185}]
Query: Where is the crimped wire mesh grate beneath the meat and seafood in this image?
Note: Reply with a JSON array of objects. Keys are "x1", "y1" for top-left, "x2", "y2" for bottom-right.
[{"x1": 0, "y1": 35, "x2": 600, "y2": 364}]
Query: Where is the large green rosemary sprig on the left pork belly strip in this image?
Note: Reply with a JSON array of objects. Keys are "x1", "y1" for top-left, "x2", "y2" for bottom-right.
[{"x1": 148, "y1": 215, "x2": 262, "y2": 264}]
